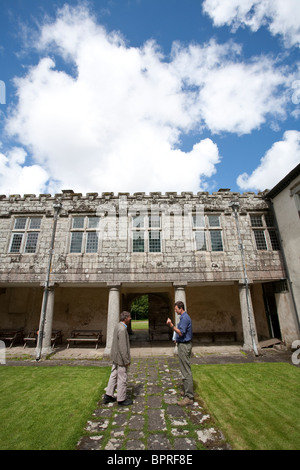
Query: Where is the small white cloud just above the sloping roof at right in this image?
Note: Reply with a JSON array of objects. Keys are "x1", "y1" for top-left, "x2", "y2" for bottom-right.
[{"x1": 237, "y1": 131, "x2": 300, "y2": 191}]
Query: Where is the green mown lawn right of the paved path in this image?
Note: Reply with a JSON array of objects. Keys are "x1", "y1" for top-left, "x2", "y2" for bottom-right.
[{"x1": 193, "y1": 363, "x2": 300, "y2": 450}]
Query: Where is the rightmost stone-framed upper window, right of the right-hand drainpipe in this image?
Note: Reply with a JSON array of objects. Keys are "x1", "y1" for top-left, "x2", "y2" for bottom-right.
[{"x1": 249, "y1": 212, "x2": 281, "y2": 251}]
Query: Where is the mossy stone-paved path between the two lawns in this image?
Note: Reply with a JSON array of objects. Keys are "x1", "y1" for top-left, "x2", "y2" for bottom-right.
[{"x1": 77, "y1": 357, "x2": 230, "y2": 451}]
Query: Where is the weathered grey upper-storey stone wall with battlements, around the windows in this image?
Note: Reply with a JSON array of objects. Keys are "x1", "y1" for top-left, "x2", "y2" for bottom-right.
[{"x1": 0, "y1": 190, "x2": 285, "y2": 286}]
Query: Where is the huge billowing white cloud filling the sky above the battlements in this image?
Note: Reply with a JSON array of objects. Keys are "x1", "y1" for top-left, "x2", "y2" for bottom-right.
[{"x1": 2, "y1": 7, "x2": 291, "y2": 192}]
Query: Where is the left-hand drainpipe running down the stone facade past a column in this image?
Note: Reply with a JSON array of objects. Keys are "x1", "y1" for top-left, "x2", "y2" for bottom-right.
[{"x1": 36, "y1": 202, "x2": 62, "y2": 361}]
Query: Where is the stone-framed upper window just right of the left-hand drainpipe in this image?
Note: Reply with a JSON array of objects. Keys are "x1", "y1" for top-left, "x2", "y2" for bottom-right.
[{"x1": 68, "y1": 214, "x2": 101, "y2": 255}]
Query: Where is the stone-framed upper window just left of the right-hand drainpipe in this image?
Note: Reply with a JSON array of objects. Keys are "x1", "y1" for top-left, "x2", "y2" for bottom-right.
[{"x1": 191, "y1": 212, "x2": 225, "y2": 253}]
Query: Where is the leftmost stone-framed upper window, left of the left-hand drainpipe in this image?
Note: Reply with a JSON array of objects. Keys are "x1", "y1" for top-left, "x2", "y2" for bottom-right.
[{"x1": 8, "y1": 215, "x2": 43, "y2": 255}]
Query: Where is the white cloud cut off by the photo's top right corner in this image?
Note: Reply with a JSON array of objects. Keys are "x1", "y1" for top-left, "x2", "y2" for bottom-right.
[{"x1": 203, "y1": 0, "x2": 300, "y2": 47}]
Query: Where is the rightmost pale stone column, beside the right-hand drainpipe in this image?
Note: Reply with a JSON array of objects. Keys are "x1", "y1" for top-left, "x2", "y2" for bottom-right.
[{"x1": 239, "y1": 284, "x2": 258, "y2": 352}]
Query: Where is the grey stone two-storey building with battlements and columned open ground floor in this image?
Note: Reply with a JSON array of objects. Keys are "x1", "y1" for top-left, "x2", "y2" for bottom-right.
[{"x1": 0, "y1": 189, "x2": 299, "y2": 353}]
